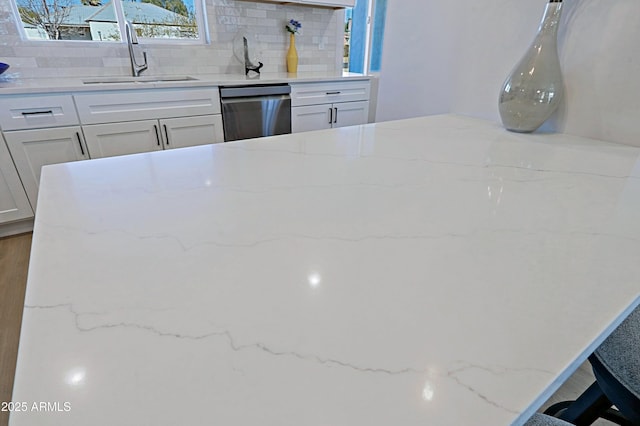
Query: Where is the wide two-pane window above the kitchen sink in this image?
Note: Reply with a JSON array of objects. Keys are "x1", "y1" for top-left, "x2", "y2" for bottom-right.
[{"x1": 15, "y1": 0, "x2": 206, "y2": 42}]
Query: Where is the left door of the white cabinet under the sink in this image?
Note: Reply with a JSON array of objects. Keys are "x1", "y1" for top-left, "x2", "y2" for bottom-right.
[{"x1": 82, "y1": 120, "x2": 162, "y2": 158}]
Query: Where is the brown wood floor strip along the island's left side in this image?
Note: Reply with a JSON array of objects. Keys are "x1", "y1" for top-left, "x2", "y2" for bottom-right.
[{"x1": 0, "y1": 233, "x2": 31, "y2": 426}]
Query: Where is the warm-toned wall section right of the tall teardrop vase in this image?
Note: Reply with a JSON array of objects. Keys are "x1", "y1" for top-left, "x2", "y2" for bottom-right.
[{"x1": 558, "y1": 0, "x2": 640, "y2": 146}]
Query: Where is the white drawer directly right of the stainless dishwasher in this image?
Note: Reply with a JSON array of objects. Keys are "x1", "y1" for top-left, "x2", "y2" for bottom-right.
[{"x1": 291, "y1": 80, "x2": 370, "y2": 106}]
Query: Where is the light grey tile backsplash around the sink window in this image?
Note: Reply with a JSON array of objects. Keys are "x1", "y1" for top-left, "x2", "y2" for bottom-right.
[{"x1": 0, "y1": 0, "x2": 344, "y2": 78}]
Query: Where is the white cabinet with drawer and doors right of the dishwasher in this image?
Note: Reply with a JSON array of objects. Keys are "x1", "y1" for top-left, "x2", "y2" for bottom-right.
[{"x1": 291, "y1": 80, "x2": 370, "y2": 133}]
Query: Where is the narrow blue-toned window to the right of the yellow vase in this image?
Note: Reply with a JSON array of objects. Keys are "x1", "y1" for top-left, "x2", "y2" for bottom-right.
[{"x1": 343, "y1": 0, "x2": 387, "y2": 73}]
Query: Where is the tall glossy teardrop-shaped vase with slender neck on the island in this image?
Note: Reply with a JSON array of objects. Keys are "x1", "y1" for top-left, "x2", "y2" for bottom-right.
[{"x1": 498, "y1": 0, "x2": 564, "y2": 133}]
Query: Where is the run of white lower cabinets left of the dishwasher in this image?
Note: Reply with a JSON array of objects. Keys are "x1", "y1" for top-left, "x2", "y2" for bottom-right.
[{"x1": 0, "y1": 86, "x2": 224, "y2": 223}]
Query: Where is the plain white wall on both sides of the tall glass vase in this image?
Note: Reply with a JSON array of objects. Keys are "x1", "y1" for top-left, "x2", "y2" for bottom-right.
[{"x1": 376, "y1": 0, "x2": 640, "y2": 146}]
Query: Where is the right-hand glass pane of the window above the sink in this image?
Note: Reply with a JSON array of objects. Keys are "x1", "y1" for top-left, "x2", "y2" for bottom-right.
[{"x1": 122, "y1": 0, "x2": 198, "y2": 39}]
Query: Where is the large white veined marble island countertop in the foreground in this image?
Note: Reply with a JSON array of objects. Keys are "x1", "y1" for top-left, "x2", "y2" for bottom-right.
[{"x1": 10, "y1": 116, "x2": 640, "y2": 426}]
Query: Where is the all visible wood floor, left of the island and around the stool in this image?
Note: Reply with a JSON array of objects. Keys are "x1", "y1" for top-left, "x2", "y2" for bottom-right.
[{"x1": 0, "y1": 233, "x2": 612, "y2": 426}]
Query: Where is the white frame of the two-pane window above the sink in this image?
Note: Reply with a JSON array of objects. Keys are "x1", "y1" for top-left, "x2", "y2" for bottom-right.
[{"x1": 9, "y1": 0, "x2": 211, "y2": 46}]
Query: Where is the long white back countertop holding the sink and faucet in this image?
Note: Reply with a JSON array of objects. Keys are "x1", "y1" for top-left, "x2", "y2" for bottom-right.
[{"x1": 0, "y1": 72, "x2": 369, "y2": 96}]
